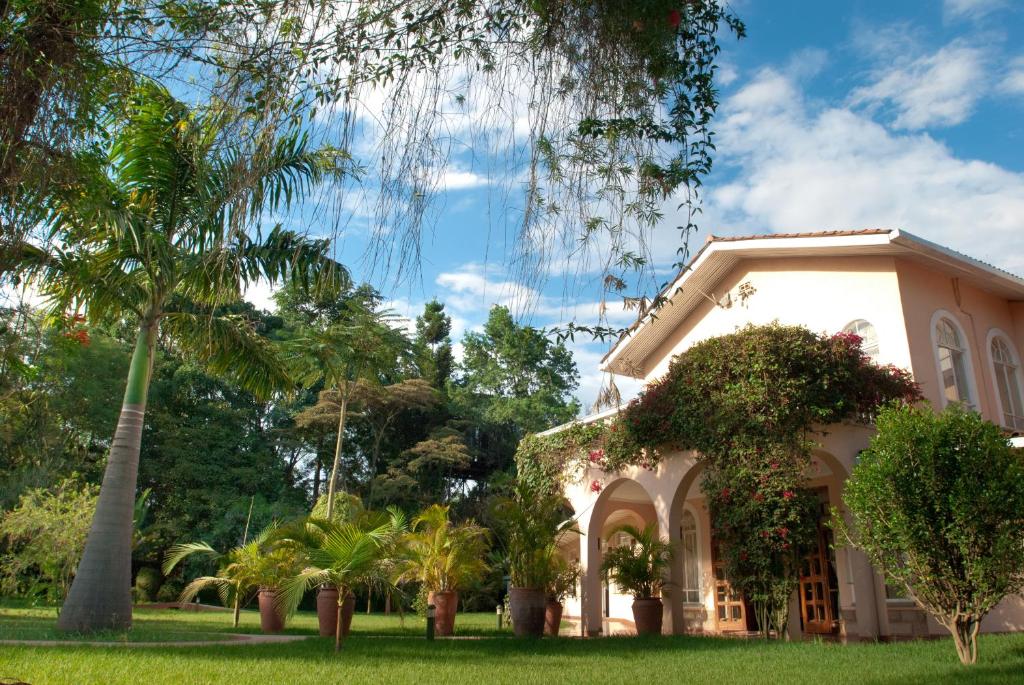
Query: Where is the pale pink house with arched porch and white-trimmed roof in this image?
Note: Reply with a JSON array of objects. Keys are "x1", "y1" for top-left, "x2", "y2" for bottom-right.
[{"x1": 549, "y1": 229, "x2": 1024, "y2": 640}]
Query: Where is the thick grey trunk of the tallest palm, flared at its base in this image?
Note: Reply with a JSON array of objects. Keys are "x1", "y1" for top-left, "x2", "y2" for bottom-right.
[{"x1": 57, "y1": 317, "x2": 157, "y2": 632}]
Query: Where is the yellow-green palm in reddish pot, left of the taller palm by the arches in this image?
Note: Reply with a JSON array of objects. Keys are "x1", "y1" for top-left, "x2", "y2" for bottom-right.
[{"x1": 398, "y1": 504, "x2": 488, "y2": 636}]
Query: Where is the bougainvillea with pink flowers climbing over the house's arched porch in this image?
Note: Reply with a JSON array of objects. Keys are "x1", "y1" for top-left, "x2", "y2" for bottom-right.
[{"x1": 517, "y1": 324, "x2": 920, "y2": 635}]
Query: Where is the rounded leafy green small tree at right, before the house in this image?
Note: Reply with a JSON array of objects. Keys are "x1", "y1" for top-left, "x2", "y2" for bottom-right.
[{"x1": 834, "y1": 404, "x2": 1024, "y2": 665}]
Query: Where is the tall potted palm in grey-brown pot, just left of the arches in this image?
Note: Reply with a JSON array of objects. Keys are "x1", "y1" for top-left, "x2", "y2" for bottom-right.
[{"x1": 492, "y1": 481, "x2": 575, "y2": 637}]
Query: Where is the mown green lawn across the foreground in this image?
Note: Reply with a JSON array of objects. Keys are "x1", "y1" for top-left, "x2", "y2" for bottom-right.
[{"x1": 0, "y1": 608, "x2": 1024, "y2": 685}]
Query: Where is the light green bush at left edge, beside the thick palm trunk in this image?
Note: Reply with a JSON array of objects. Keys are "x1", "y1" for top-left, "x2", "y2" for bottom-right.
[{"x1": 0, "y1": 478, "x2": 98, "y2": 603}]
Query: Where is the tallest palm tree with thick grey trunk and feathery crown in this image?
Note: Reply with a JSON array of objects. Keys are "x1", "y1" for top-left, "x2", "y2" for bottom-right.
[{"x1": 19, "y1": 83, "x2": 347, "y2": 631}]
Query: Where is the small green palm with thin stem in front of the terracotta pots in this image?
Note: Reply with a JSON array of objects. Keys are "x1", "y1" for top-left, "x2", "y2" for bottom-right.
[{"x1": 280, "y1": 508, "x2": 408, "y2": 651}]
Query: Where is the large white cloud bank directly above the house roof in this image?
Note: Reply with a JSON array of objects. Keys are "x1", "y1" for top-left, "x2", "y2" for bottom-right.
[{"x1": 702, "y1": 70, "x2": 1024, "y2": 272}]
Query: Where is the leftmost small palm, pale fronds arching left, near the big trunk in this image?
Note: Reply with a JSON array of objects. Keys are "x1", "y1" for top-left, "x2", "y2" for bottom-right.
[{"x1": 163, "y1": 523, "x2": 299, "y2": 628}]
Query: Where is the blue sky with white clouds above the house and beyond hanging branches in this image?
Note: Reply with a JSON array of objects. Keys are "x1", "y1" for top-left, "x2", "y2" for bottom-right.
[{"x1": 249, "y1": 0, "x2": 1024, "y2": 409}]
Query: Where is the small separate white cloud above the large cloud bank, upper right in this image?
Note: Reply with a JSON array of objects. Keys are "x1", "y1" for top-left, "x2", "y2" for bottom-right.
[{"x1": 850, "y1": 40, "x2": 986, "y2": 129}]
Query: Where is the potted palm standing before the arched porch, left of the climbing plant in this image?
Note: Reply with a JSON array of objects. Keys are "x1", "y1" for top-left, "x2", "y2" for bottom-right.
[{"x1": 601, "y1": 523, "x2": 672, "y2": 635}]
